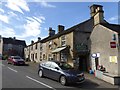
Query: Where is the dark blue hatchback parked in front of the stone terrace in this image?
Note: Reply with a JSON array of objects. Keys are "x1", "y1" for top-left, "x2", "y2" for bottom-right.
[{"x1": 38, "y1": 61, "x2": 85, "y2": 85}]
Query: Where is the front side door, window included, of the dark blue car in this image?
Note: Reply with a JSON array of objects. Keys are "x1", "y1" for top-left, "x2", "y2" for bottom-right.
[{"x1": 50, "y1": 62, "x2": 61, "y2": 80}]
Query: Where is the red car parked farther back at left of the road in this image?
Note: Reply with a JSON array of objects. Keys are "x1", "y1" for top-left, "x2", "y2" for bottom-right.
[{"x1": 7, "y1": 56, "x2": 25, "y2": 65}]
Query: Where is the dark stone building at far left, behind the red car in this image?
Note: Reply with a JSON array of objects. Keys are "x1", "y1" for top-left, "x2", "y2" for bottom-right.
[{"x1": 0, "y1": 36, "x2": 26, "y2": 57}]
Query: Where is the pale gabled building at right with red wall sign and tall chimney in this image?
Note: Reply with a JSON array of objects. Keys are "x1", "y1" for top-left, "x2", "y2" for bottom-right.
[{"x1": 90, "y1": 5, "x2": 120, "y2": 84}]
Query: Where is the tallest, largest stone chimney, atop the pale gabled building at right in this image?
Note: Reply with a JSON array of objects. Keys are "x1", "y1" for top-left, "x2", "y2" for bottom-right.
[{"x1": 90, "y1": 4, "x2": 105, "y2": 25}]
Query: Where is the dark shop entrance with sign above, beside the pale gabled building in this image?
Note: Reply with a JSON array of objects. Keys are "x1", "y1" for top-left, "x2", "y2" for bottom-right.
[{"x1": 74, "y1": 44, "x2": 89, "y2": 71}]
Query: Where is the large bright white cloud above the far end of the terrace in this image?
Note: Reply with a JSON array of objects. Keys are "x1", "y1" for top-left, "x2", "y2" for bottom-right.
[{"x1": 22, "y1": 16, "x2": 45, "y2": 38}]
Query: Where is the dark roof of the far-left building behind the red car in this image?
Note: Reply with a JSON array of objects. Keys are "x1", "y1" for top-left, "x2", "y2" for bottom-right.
[{"x1": 3, "y1": 37, "x2": 26, "y2": 46}]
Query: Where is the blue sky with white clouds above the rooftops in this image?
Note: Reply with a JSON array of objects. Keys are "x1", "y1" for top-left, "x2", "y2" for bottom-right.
[{"x1": 0, "y1": 0, "x2": 119, "y2": 45}]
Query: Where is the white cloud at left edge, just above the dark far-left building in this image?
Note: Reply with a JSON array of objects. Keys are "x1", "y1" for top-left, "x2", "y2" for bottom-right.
[{"x1": 0, "y1": 27, "x2": 15, "y2": 37}]
